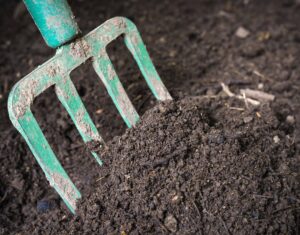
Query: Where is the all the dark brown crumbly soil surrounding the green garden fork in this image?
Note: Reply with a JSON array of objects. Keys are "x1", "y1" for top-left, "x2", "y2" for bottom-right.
[{"x1": 0, "y1": 0, "x2": 300, "y2": 234}]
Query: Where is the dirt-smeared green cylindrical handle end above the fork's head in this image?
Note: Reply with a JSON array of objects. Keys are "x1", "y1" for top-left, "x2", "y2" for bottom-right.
[{"x1": 23, "y1": 0, "x2": 79, "y2": 48}]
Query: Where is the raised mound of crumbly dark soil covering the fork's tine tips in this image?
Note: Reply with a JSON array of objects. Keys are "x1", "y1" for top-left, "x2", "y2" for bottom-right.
[{"x1": 23, "y1": 97, "x2": 300, "y2": 235}]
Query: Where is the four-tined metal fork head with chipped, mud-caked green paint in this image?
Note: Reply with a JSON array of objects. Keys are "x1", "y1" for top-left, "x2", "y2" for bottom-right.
[{"x1": 8, "y1": 17, "x2": 172, "y2": 213}]
